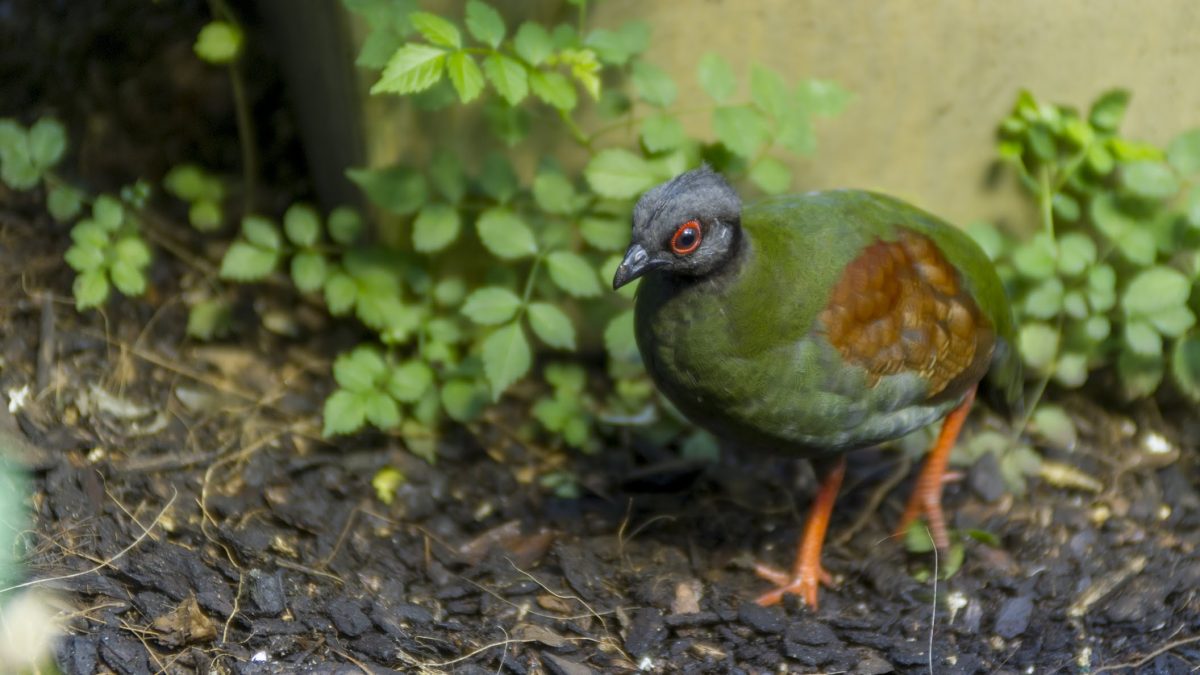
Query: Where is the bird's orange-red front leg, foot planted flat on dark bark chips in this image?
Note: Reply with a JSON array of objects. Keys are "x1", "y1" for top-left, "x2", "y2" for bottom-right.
[{"x1": 755, "y1": 455, "x2": 846, "y2": 609}]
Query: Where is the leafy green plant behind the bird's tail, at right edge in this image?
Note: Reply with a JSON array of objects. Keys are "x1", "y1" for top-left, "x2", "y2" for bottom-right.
[{"x1": 970, "y1": 90, "x2": 1200, "y2": 400}]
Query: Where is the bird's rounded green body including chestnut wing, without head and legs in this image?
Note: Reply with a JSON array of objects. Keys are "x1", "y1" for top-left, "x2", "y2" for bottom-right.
[{"x1": 637, "y1": 190, "x2": 1019, "y2": 455}]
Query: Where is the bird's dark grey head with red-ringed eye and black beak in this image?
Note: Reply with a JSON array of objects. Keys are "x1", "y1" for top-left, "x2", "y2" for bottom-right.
[{"x1": 612, "y1": 166, "x2": 742, "y2": 288}]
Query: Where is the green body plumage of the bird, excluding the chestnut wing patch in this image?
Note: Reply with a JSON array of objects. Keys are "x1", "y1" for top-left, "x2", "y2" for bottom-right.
[{"x1": 635, "y1": 190, "x2": 1020, "y2": 456}]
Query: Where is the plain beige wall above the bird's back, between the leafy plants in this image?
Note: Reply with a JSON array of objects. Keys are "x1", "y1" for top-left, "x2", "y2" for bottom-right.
[{"x1": 592, "y1": 0, "x2": 1200, "y2": 223}]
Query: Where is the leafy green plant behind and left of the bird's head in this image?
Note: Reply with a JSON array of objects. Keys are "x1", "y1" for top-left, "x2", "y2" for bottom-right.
[{"x1": 274, "y1": 0, "x2": 848, "y2": 449}]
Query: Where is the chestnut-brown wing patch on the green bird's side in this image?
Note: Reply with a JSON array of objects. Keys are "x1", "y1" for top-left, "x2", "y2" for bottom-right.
[{"x1": 821, "y1": 228, "x2": 995, "y2": 399}]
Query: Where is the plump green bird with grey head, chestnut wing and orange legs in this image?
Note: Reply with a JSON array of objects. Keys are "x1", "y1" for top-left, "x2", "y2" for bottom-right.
[{"x1": 612, "y1": 165, "x2": 1022, "y2": 609}]
